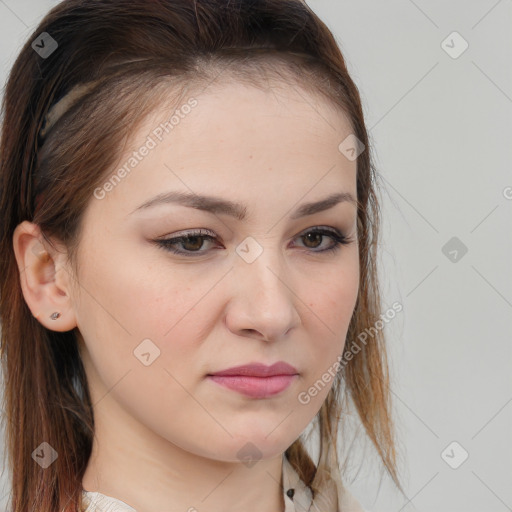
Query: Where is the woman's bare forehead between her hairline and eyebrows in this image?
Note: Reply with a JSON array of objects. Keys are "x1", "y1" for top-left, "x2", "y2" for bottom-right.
[{"x1": 86, "y1": 82, "x2": 356, "y2": 223}]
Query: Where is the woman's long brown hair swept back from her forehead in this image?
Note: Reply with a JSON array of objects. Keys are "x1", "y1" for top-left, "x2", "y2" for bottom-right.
[{"x1": 0, "y1": 0, "x2": 400, "y2": 512}]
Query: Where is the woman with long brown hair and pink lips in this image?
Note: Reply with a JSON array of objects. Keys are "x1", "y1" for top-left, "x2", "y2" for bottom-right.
[{"x1": 0, "y1": 0, "x2": 399, "y2": 512}]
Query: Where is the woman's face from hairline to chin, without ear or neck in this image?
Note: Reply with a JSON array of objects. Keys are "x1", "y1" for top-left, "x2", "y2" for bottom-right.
[{"x1": 50, "y1": 83, "x2": 359, "y2": 461}]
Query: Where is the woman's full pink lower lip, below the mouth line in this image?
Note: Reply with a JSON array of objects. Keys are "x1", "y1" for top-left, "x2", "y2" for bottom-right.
[{"x1": 208, "y1": 375, "x2": 297, "y2": 398}]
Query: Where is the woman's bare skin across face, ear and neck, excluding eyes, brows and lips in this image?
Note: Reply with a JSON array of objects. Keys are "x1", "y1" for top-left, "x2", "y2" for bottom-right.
[{"x1": 13, "y1": 81, "x2": 359, "y2": 512}]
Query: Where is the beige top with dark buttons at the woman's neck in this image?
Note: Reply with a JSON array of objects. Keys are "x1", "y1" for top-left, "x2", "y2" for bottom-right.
[{"x1": 82, "y1": 454, "x2": 365, "y2": 512}]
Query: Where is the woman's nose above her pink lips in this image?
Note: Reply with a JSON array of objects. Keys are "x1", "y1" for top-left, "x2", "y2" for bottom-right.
[{"x1": 226, "y1": 248, "x2": 301, "y2": 341}]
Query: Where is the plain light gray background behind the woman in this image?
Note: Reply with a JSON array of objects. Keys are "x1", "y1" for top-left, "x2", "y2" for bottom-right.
[{"x1": 0, "y1": 0, "x2": 512, "y2": 512}]
